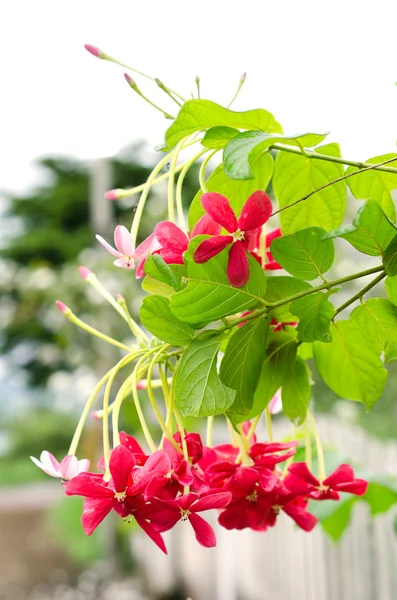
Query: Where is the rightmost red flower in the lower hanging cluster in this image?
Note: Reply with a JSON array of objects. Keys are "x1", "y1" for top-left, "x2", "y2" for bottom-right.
[{"x1": 285, "y1": 462, "x2": 368, "y2": 500}]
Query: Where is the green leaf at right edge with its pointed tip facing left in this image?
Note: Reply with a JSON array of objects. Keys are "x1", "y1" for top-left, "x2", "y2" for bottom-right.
[{"x1": 323, "y1": 200, "x2": 397, "y2": 256}]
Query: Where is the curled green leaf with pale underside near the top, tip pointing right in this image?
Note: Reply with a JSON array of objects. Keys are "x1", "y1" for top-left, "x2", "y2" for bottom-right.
[{"x1": 223, "y1": 131, "x2": 328, "y2": 179}]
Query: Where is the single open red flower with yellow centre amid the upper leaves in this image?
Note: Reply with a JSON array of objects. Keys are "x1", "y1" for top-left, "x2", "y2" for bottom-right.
[{"x1": 194, "y1": 190, "x2": 272, "y2": 287}]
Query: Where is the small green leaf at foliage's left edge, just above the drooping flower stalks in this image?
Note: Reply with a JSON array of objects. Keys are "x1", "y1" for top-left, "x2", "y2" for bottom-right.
[{"x1": 140, "y1": 296, "x2": 195, "y2": 346}]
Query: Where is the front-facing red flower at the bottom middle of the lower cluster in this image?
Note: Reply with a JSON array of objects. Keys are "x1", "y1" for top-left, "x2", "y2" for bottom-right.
[{"x1": 146, "y1": 492, "x2": 232, "y2": 548}]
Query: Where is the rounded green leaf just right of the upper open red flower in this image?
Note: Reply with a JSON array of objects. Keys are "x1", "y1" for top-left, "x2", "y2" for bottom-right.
[{"x1": 270, "y1": 227, "x2": 335, "y2": 281}]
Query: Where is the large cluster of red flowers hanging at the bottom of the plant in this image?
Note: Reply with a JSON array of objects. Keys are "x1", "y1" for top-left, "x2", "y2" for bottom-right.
[{"x1": 66, "y1": 426, "x2": 367, "y2": 553}]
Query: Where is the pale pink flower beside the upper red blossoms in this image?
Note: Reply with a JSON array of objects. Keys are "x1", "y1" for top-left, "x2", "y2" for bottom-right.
[{"x1": 95, "y1": 225, "x2": 159, "y2": 269}]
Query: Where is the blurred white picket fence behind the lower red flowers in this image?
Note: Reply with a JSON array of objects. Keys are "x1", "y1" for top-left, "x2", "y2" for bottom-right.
[{"x1": 132, "y1": 419, "x2": 397, "y2": 600}]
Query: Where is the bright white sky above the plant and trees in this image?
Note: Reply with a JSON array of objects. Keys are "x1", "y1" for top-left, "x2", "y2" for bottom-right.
[{"x1": 0, "y1": 0, "x2": 397, "y2": 195}]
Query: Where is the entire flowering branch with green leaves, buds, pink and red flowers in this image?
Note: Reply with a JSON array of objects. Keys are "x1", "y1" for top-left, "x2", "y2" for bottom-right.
[{"x1": 33, "y1": 41, "x2": 397, "y2": 552}]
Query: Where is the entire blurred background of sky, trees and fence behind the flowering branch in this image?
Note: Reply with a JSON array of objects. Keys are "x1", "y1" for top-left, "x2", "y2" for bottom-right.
[{"x1": 0, "y1": 0, "x2": 397, "y2": 600}]
